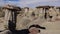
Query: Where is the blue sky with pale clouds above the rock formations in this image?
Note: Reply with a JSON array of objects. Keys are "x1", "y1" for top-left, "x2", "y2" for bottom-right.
[{"x1": 0, "y1": 0, "x2": 60, "y2": 8}]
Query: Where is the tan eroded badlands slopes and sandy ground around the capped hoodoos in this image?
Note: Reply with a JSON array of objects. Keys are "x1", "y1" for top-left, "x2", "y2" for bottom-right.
[{"x1": 0, "y1": 8, "x2": 60, "y2": 34}]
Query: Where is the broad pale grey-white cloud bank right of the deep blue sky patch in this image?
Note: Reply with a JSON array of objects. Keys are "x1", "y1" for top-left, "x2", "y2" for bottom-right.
[{"x1": 19, "y1": 0, "x2": 60, "y2": 7}]
